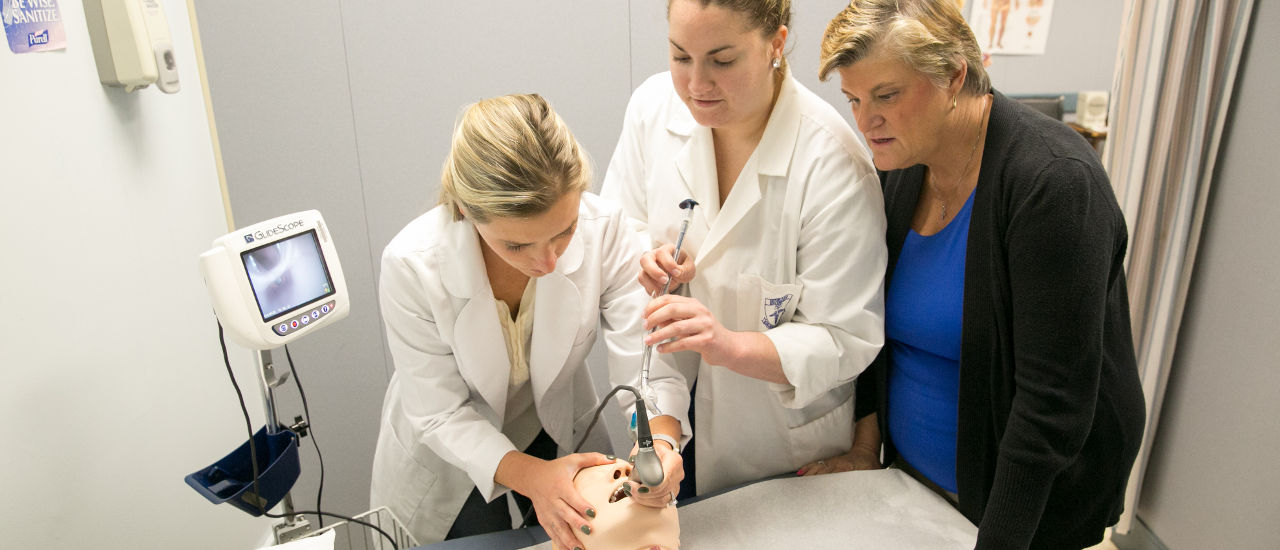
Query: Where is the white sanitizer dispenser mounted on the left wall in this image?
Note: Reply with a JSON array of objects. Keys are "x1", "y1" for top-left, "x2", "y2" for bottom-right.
[{"x1": 84, "y1": 0, "x2": 180, "y2": 93}]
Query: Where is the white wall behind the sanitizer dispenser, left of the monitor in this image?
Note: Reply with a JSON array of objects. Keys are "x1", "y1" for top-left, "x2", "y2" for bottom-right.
[{"x1": 0, "y1": 0, "x2": 268, "y2": 549}]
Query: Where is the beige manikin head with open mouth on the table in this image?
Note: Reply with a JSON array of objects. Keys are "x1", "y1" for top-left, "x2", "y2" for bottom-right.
[{"x1": 555, "y1": 460, "x2": 680, "y2": 550}]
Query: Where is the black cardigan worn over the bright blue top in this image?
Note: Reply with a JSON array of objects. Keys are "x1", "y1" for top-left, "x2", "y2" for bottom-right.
[{"x1": 858, "y1": 92, "x2": 1146, "y2": 549}]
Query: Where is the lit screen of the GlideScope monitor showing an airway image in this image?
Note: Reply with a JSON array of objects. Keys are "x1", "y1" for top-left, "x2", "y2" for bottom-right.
[{"x1": 242, "y1": 230, "x2": 333, "y2": 321}]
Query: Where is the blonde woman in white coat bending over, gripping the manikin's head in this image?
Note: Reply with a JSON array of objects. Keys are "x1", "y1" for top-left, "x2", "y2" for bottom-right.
[{"x1": 370, "y1": 95, "x2": 689, "y2": 549}]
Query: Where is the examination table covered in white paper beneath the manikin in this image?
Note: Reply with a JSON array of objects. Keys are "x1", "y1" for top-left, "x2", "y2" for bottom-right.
[{"x1": 420, "y1": 469, "x2": 978, "y2": 550}]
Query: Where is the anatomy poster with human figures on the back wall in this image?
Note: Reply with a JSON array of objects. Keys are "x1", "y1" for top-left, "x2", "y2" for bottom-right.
[{"x1": 969, "y1": 0, "x2": 1053, "y2": 55}]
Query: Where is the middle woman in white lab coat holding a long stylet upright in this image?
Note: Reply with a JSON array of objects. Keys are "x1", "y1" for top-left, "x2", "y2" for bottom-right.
[{"x1": 602, "y1": 0, "x2": 886, "y2": 498}]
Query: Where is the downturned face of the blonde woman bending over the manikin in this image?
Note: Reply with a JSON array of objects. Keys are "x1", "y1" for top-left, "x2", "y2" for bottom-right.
[{"x1": 475, "y1": 193, "x2": 582, "y2": 279}]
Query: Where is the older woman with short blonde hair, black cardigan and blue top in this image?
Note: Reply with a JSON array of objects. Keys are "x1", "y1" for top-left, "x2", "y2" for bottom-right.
[{"x1": 806, "y1": 0, "x2": 1144, "y2": 549}]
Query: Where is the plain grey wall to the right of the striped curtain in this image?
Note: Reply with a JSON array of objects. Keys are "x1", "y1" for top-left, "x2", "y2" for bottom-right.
[{"x1": 1138, "y1": 1, "x2": 1280, "y2": 550}]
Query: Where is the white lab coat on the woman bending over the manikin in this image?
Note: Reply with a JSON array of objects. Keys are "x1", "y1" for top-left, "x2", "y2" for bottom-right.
[{"x1": 370, "y1": 193, "x2": 689, "y2": 544}]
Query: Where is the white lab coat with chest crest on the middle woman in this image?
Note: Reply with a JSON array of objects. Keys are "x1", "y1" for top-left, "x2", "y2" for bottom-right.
[{"x1": 602, "y1": 73, "x2": 887, "y2": 494}]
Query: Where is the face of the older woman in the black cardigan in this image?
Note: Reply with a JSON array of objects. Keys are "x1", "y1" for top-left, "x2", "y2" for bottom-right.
[{"x1": 836, "y1": 51, "x2": 957, "y2": 170}]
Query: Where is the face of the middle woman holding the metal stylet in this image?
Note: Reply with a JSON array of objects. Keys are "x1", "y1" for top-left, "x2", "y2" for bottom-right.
[{"x1": 667, "y1": 0, "x2": 787, "y2": 133}]
